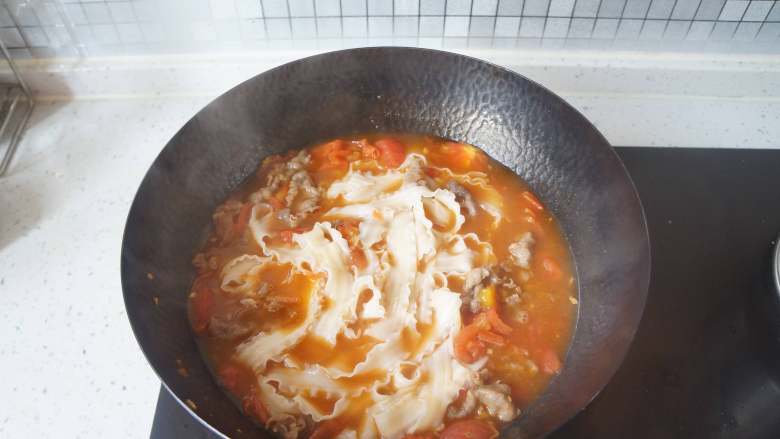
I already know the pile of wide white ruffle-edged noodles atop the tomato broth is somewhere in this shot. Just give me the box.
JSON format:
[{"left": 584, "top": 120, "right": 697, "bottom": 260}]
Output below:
[{"left": 223, "top": 154, "right": 502, "bottom": 438}]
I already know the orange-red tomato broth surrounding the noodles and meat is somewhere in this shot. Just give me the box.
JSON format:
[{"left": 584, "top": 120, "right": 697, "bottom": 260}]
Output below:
[{"left": 189, "top": 135, "right": 577, "bottom": 437}]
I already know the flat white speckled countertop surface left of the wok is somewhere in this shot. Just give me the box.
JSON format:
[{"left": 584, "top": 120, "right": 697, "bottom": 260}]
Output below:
[{"left": 0, "top": 98, "right": 207, "bottom": 438}]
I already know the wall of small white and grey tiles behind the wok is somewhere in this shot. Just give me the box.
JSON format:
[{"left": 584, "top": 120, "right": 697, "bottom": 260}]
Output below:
[{"left": 0, "top": 0, "right": 780, "bottom": 57}]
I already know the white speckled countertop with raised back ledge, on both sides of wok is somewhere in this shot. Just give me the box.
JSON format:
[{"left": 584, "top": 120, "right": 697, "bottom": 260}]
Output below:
[{"left": 0, "top": 47, "right": 780, "bottom": 438}]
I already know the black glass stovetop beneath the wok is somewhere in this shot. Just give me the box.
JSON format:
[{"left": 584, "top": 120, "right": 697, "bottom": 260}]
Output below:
[{"left": 151, "top": 148, "right": 780, "bottom": 439}]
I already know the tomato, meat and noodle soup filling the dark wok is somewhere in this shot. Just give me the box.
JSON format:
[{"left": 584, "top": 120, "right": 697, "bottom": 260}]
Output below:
[{"left": 189, "top": 134, "right": 577, "bottom": 439}]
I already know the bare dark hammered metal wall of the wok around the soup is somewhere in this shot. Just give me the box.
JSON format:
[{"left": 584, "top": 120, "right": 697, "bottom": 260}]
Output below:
[{"left": 121, "top": 48, "right": 650, "bottom": 438}]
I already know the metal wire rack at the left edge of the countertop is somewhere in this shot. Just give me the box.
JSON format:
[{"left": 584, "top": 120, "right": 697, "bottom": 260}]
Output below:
[{"left": 0, "top": 33, "right": 35, "bottom": 177}]
